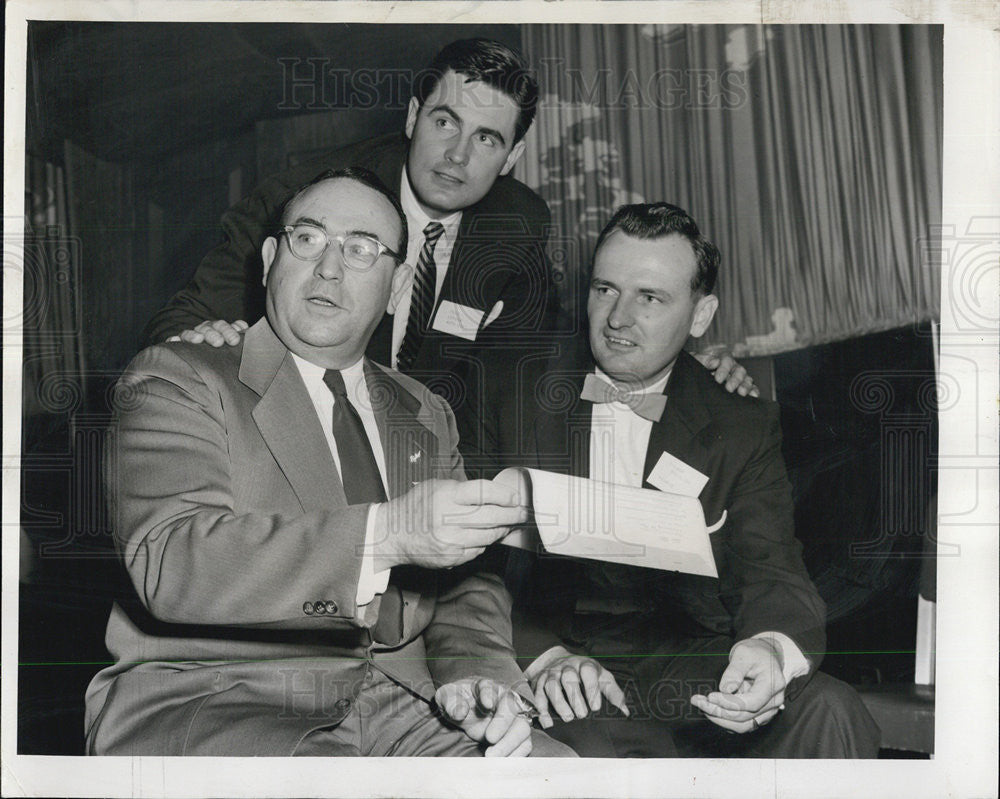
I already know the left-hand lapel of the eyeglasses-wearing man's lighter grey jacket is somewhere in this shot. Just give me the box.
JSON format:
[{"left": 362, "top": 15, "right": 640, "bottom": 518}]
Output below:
[{"left": 240, "top": 319, "right": 347, "bottom": 513}]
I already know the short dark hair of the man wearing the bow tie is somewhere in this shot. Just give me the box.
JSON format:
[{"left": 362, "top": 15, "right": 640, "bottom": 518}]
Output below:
[{"left": 594, "top": 203, "right": 722, "bottom": 295}]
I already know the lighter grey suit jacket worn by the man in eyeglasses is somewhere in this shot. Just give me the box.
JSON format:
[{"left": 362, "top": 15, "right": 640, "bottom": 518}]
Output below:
[{"left": 86, "top": 320, "right": 522, "bottom": 755}]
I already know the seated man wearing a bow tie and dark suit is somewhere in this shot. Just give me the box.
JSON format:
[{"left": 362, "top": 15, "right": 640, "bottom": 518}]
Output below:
[{"left": 460, "top": 203, "right": 878, "bottom": 757}]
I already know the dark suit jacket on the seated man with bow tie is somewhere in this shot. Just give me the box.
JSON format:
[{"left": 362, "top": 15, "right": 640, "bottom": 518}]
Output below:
[{"left": 459, "top": 352, "right": 825, "bottom": 666}]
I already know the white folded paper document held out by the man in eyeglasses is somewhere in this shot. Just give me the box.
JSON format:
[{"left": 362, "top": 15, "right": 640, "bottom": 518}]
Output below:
[{"left": 494, "top": 468, "right": 725, "bottom": 577}]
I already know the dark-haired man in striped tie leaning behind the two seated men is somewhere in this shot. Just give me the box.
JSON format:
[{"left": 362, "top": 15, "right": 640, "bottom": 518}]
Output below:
[{"left": 144, "top": 39, "right": 755, "bottom": 396}]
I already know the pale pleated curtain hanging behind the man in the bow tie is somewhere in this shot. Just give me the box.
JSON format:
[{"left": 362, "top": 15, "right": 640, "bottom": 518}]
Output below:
[{"left": 517, "top": 25, "right": 942, "bottom": 355}]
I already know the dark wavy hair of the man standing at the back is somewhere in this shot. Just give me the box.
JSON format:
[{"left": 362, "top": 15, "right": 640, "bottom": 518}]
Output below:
[{"left": 413, "top": 39, "right": 538, "bottom": 145}]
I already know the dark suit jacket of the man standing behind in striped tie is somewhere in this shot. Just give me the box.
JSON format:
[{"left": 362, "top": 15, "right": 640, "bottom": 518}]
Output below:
[{"left": 143, "top": 134, "right": 555, "bottom": 382}]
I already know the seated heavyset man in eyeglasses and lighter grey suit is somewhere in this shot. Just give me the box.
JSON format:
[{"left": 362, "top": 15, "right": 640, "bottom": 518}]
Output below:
[{"left": 86, "top": 169, "right": 572, "bottom": 756}]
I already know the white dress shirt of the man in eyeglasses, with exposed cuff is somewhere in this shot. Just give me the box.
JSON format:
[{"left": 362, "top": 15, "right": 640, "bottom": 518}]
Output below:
[{"left": 291, "top": 352, "right": 392, "bottom": 618}]
